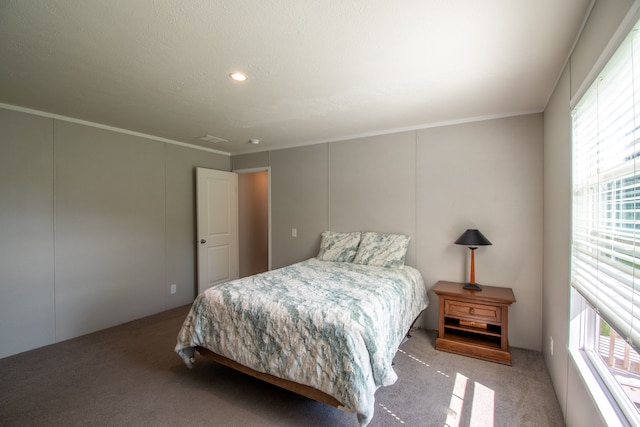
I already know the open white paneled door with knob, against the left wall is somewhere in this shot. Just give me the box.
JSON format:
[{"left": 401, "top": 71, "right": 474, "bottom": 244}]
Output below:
[{"left": 196, "top": 168, "right": 238, "bottom": 293}]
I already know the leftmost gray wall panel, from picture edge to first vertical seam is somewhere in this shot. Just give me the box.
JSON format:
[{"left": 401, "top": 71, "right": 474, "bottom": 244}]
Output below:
[{"left": 0, "top": 109, "right": 56, "bottom": 357}]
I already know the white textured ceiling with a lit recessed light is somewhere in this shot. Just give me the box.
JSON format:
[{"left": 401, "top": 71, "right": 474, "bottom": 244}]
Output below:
[{"left": 0, "top": 0, "right": 591, "bottom": 154}]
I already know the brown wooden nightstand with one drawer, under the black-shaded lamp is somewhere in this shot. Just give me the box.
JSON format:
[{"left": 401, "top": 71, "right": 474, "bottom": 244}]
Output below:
[{"left": 433, "top": 281, "right": 516, "bottom": 365}]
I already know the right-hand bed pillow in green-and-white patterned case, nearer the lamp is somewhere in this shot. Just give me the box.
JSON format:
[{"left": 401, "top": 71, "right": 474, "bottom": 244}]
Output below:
[{"left": 353, "top": 231, "right": 411, "bottom": 268}]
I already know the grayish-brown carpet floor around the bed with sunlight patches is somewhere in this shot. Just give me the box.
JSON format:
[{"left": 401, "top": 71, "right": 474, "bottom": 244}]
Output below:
[{"left": 0, "top": 307, "right": 564, "bottom": 427}]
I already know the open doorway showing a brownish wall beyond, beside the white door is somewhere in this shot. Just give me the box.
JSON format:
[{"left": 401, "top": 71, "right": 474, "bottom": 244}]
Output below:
[{"left": 234, "top": 168, "right": 271, "bottom": 277}]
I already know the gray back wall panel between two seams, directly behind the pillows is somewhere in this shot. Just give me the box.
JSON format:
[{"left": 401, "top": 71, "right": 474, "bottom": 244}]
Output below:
[{"left": 332, "top": 132, "right": 418, "bottom": 266}]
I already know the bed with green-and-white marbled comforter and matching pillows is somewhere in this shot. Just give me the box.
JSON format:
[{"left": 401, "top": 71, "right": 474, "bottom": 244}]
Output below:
[{"left": 175, "top": 232, "right": 428, "bottom": 425}]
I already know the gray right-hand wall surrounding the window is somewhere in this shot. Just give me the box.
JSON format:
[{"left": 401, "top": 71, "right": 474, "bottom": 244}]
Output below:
[{"left": 542, "top": 0, "right": 633, "bottom": 426}]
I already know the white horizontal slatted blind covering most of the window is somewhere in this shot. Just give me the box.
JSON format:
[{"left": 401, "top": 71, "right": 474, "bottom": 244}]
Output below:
[{"left": 572, "top": 24, "right": 640, "bottom": 349}]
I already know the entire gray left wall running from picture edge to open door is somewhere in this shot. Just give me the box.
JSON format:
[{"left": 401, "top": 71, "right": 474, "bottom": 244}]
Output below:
[{"left": 0, "top": 109, "right": 231, "bottom": 357}]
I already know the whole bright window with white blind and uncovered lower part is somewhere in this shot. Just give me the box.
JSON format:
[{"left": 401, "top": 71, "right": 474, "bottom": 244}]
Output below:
[{"left": 571, "top": 18, "right": 640, "bottom": 425}]
